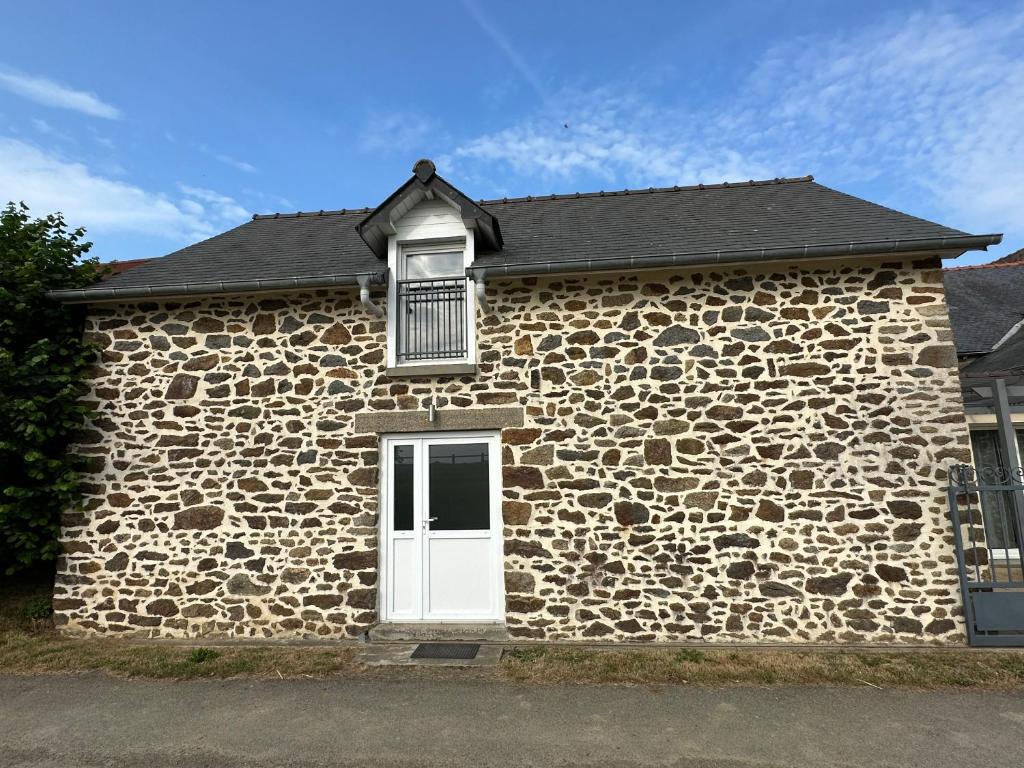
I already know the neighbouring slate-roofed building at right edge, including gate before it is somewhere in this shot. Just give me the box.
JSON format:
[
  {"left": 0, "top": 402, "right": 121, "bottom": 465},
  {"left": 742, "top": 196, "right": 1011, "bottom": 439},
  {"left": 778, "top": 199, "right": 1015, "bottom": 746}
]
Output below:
[{"left": 945, "top": 257, "right": 1024, "bottom": 645}]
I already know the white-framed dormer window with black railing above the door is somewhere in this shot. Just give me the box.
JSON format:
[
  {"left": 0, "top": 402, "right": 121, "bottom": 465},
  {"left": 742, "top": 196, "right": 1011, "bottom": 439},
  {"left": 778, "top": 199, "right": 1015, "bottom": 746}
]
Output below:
[{"left": 391, "top": 244, "right": 470, "bottom": 366}]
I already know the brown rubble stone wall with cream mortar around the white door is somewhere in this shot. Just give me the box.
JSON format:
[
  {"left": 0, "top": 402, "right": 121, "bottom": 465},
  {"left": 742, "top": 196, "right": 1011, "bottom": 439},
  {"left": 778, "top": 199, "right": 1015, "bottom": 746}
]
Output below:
[{"left": 55, "top": 260, "right": 969, "bottom": 643}]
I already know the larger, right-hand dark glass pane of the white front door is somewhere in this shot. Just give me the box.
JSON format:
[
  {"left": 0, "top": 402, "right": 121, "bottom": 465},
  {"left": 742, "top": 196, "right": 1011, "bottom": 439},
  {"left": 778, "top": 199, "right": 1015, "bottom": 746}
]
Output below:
[{"left": 429, "top": 442, "right": 490, "bottom": 530}]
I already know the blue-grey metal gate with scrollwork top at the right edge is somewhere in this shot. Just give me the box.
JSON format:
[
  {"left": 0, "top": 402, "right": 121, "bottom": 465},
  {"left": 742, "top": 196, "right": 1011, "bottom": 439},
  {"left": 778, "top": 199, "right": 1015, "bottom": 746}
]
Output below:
[{"left": 948, "top": 464, "right": 1024, "bottom": 646}]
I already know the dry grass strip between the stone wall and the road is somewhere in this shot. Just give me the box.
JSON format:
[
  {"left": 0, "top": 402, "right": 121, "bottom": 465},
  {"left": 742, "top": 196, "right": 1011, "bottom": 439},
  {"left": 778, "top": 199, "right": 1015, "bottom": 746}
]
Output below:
[{"left": 6, "top": 577, "right": 1024, "bottom": 690}]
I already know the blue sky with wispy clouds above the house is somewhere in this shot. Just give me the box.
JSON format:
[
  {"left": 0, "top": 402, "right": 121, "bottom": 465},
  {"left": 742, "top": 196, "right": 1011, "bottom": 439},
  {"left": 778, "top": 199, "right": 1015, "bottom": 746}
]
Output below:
[{"left": 0, "top": 0, "right": 1024, "bottom": 263}]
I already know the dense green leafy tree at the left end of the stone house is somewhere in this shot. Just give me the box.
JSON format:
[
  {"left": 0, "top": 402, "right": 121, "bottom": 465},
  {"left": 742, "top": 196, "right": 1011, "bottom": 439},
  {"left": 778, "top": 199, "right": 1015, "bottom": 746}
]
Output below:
[{"left": 0, "top": 203, "right": 100, "bottom": 573}]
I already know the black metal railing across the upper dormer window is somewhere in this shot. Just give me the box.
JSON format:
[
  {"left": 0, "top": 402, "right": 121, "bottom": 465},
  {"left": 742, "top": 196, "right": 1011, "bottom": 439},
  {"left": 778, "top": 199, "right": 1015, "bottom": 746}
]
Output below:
[{"left": 395, "top": 278, "right": 467, "bottom": 365}]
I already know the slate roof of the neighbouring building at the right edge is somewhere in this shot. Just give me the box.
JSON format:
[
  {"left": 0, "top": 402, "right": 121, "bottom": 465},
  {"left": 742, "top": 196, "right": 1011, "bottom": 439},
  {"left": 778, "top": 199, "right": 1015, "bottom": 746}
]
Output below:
[{"left": 943, "top": 262, "right": 1024, "bottom": 354}]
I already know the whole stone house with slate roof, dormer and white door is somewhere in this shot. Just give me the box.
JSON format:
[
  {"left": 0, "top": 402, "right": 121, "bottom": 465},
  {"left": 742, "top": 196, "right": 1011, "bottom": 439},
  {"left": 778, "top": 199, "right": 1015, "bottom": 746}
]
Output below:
[{"left": 48, "top": 161, "right": 1000, "bottom": 643}]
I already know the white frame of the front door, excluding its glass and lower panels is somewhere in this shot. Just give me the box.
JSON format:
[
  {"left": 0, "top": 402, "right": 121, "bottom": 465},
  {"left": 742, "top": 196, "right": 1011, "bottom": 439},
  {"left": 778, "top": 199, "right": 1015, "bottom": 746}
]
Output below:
[{"left": 378, "top": 430, "right": 505, "bottom": 624}]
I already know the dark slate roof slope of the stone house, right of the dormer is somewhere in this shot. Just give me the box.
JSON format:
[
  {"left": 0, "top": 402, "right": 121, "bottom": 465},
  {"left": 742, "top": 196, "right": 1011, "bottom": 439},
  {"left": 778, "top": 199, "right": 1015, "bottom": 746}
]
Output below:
[{"left": 476, "top": 176, "right": 966, "bottom": 266}]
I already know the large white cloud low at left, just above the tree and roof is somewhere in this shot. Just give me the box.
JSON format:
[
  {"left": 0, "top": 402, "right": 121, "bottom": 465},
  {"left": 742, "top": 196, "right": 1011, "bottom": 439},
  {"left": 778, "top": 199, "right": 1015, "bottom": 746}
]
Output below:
[{"left": 0, "top": 137, "right": 248, "bottom": 243}]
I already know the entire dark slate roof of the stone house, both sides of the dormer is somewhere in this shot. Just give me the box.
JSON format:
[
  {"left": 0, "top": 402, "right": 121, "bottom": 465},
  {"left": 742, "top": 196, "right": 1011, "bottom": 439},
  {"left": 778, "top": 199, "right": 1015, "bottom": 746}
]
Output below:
[{"left": 55, "top": 176, "right": 998, "bottom": 300}]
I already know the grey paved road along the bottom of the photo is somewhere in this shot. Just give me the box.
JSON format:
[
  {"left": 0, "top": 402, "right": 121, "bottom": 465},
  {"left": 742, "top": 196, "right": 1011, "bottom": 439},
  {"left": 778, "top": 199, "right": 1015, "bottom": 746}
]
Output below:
[{"left": 0, "top": 675, "right": 1024, "bottom": 768}]
